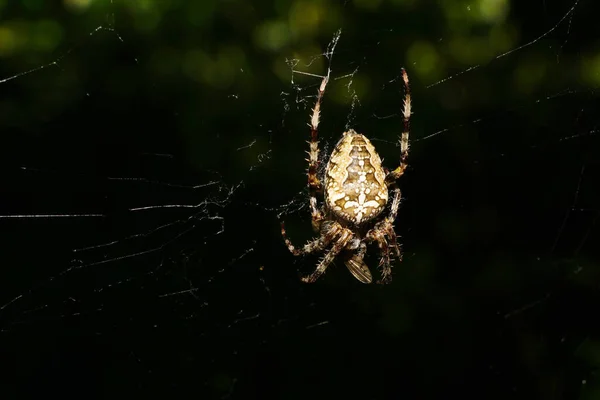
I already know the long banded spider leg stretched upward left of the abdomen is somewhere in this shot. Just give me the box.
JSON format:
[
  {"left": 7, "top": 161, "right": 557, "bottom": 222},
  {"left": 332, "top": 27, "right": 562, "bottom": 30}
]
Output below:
[{"left": 306, "top": 75, "right": 329, "bottom": 232}]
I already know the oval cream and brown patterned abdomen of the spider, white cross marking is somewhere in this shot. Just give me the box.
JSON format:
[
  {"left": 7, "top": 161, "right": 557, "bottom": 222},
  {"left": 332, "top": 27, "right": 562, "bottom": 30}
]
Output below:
[{"left": 325, "top": 129, "right": 388, "bottom": 225}]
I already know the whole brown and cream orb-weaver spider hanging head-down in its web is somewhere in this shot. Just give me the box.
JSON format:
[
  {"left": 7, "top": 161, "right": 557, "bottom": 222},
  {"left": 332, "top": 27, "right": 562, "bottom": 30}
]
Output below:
[{"left": 281, "top": 68, "right": 411, "bottom": 283}]
